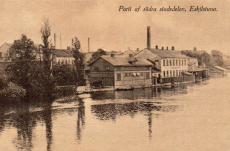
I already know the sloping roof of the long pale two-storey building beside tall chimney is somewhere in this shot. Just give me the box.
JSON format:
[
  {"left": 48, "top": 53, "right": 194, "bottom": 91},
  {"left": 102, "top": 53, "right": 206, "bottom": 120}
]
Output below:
[{"left": 140, "top": 49, "right": 188, "bottom": 59}]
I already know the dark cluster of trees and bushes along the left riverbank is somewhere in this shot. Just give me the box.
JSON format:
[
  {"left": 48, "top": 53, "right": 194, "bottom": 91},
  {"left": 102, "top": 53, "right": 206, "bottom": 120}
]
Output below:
[{"left": 0, "top": 19, "right": 84, "bottom": 100}]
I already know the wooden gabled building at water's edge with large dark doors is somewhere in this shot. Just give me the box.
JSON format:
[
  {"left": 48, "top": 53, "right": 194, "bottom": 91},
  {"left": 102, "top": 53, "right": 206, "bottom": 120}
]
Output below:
[{"left": 88, "top": 54, "right": 152, "bottom": 89}]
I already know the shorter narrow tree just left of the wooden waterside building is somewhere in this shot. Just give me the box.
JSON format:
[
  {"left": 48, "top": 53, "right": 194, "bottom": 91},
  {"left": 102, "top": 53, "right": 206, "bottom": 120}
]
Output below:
[{"left": 72, "top": 37, "right": 85, "bottom": 86}]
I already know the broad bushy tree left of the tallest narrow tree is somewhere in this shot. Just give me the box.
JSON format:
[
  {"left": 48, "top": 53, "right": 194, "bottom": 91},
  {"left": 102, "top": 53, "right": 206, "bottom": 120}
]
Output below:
[{"left": 8, "top": 35, "right": 36, "bottom": 89}]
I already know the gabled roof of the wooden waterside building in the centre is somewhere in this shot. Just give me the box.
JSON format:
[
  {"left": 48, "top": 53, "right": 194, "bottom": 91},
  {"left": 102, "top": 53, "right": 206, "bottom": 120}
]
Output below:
[{"left": 89, "top": 55, "right": 152, "bottom": 66}]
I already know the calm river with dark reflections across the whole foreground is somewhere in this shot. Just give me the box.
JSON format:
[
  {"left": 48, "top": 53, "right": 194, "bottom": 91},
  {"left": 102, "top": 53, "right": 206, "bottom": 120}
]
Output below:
[{"left": 0, "top": 77, "right": 230, "bottom": 151}]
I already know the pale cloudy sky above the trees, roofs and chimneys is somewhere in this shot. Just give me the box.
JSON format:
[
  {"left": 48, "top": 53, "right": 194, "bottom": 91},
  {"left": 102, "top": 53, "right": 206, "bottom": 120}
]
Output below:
[{"left": 0, "top": 0, "right": 230, "bottom": 54}]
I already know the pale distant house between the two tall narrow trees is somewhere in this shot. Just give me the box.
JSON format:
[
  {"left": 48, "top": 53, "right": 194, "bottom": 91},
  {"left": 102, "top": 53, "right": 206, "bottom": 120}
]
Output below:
[{"left": 52, "top": 49, "right": 74, "bottom": 65}]
